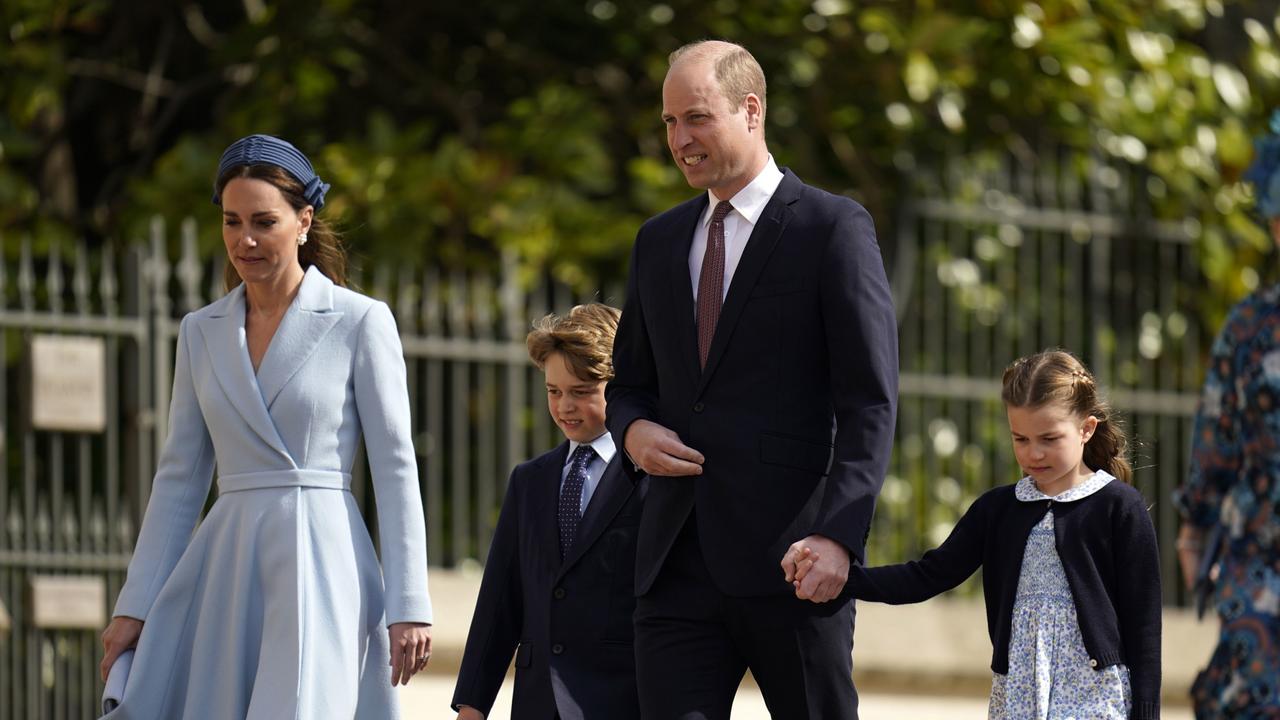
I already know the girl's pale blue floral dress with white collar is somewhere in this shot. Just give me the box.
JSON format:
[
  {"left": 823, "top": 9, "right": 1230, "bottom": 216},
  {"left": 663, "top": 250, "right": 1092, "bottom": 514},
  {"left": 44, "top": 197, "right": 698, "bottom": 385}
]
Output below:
[{"left": 988, "top": 470, "right": 1133, "bottom": 720}]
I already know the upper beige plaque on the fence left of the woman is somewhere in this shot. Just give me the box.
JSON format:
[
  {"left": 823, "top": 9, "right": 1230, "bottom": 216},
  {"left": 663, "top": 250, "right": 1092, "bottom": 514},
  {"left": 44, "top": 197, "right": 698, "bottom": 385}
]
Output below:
[{"left": 31, "top": 334, "right": 106, "bottom": 433}]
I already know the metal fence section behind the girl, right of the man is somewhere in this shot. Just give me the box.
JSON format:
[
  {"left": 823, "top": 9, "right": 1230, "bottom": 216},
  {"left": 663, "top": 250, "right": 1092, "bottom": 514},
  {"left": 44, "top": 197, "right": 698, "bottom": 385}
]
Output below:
[{"left": 870, "top": 147, "right": 1216, "bottom": 602}]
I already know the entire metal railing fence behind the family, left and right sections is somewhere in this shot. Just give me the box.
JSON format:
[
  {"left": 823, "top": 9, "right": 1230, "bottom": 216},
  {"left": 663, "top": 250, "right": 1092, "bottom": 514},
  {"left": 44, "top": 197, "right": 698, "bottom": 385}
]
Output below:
[{"left": 0, "top": 146, "right": 1212, "bottom": 719}]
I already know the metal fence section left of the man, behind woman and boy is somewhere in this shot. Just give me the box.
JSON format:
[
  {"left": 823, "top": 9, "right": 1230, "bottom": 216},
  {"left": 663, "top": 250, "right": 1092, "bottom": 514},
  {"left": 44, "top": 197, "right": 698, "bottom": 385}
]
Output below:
[{"left": 0, "top": 220, "right": 622, "bottom": 719}]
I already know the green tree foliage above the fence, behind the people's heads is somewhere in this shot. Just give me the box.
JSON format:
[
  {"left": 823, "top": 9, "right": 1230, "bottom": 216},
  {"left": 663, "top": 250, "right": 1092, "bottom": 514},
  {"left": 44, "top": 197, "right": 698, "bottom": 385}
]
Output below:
[{"left": 0, "top": 0, "right": 1280, "bottom": 311}]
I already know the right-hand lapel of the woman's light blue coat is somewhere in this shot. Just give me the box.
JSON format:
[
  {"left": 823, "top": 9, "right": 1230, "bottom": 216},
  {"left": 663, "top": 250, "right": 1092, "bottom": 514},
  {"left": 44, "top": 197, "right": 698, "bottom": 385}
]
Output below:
[{"left": 257, "top": 265, "right": 342, "bottom": 410}]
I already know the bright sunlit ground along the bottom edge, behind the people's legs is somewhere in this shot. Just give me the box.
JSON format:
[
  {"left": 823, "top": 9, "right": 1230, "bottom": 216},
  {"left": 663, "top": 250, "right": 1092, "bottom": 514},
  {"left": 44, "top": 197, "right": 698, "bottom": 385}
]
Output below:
[{"left": 401, "top": 674, "right": 1192, "bottom": 720}]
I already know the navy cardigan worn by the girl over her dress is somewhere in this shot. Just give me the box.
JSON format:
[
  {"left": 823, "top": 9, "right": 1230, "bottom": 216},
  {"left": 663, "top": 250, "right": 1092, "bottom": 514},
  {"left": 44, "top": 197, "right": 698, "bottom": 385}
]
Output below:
[{"left": 849, "top": 480, "right": 1161, "bottom": 720}]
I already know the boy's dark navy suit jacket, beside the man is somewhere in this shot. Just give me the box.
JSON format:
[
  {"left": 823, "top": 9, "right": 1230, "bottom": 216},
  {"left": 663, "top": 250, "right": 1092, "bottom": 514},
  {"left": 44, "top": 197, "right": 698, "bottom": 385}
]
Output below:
[{"left": 453, "top": 441, "right": 646, "bottom": 720}]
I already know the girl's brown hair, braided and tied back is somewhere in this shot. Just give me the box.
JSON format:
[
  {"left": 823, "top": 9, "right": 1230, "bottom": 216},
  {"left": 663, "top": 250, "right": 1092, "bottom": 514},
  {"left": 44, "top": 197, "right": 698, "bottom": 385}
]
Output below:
[{"left": 1000, "top": 350, "right": 1133, "bottom": 483}]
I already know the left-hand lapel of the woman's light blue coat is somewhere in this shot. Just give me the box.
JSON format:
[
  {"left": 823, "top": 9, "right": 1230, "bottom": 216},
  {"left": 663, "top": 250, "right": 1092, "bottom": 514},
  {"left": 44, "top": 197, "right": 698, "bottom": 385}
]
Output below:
[{"left": 200, "top": 284, "right": 293, "bottom": 465}]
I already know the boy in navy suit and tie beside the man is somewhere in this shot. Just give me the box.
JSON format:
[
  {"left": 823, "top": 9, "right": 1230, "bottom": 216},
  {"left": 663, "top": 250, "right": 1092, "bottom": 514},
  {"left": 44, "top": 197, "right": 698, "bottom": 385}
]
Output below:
[{"left": 453, "top": 304, "right": 648, "bottom": 720}]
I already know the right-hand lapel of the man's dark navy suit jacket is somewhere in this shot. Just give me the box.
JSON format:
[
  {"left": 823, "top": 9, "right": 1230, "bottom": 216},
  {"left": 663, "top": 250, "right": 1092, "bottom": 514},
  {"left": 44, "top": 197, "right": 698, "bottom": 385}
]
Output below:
[{"left": 694, "top": 172, "right": 800, "bottom": 397}]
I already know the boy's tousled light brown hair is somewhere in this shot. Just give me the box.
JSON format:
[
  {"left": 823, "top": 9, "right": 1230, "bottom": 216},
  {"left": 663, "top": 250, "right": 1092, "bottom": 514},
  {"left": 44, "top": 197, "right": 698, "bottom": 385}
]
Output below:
[{"left": 525, "top": 302, "right": 621, "bottom": 380}]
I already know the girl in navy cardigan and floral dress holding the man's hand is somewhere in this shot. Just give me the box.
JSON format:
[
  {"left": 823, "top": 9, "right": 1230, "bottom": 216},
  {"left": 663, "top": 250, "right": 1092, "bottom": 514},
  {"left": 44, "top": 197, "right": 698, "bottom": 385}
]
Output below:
[{"left": 801, "top": 351, "right": 1161, "bottom": 720}]
